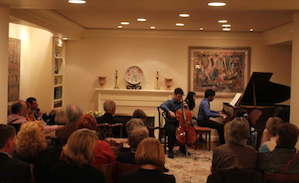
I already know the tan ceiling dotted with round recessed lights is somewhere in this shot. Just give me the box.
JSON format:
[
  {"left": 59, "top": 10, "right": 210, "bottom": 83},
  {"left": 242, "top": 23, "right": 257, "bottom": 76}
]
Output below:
[{"left": 0, "top": 0, "right": 299, "bottom": 32}]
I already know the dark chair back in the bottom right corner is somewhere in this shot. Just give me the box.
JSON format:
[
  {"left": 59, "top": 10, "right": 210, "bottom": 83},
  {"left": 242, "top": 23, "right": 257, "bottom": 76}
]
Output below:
[{"left": 264, "top": 172, "right": 299, "bottom": 183}]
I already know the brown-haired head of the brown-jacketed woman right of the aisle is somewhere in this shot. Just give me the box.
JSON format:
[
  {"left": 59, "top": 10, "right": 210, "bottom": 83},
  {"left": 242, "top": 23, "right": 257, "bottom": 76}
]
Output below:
[{"left": 228, "top": 117, "right": 250, "bottom": 145}]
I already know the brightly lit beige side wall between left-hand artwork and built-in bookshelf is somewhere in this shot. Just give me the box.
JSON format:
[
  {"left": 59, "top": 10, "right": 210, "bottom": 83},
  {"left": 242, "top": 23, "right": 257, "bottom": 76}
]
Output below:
[{"left": 9, "top": 23, "right": 53, "bottom": 111}]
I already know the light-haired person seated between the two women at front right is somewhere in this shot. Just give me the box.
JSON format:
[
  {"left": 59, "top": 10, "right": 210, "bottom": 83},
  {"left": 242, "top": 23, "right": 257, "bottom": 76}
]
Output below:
[{"left": 259, "top": 117, "right": 283, "bottom": 153}]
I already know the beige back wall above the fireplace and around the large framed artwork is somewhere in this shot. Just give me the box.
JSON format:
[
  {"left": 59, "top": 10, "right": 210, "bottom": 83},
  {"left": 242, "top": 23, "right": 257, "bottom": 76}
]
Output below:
[{"left": 65, "top": 30, "right": 291, "bottom": 113}]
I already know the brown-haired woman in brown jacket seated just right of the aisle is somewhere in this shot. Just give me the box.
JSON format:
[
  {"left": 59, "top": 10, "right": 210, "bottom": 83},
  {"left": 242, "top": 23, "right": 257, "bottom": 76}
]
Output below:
[{"left": 211, "top": 117, "right": 258, "bottom": 172}]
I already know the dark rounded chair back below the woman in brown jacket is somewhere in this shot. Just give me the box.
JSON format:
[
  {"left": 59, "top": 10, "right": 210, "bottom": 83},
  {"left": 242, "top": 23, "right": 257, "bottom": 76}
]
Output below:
[{"left": 207, "top": 169, "right": 263, "bottom": 183}]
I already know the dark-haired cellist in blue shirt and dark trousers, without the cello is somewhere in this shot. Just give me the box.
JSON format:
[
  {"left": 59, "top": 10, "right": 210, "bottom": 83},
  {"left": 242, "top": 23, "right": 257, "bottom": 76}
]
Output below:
[{"left": 160, "top": 88, "right": 190, "bottom": 158}]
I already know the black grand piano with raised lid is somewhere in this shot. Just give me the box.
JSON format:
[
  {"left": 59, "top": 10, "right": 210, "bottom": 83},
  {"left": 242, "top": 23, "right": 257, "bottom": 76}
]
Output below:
[{"left": 223, "top": 72, "right": 291, "bottom": 131}]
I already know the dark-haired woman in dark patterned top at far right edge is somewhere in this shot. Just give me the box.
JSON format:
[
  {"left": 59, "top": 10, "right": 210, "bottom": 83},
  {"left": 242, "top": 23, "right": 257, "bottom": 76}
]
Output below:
[{"left": 258, "top": 123, "right": 299, "bottom": 173}]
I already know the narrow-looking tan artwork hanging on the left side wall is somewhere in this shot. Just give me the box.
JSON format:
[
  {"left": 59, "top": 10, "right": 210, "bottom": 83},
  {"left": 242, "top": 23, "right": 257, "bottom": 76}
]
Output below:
[{"left": 8, "top": 38, "right": 21, "bottom": 102}]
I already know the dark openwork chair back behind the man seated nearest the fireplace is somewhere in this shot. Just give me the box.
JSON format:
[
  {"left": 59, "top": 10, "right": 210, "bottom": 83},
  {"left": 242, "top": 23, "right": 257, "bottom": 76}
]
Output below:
[{"left": 97, "top": 123, "right": 124, "bottom": 140}]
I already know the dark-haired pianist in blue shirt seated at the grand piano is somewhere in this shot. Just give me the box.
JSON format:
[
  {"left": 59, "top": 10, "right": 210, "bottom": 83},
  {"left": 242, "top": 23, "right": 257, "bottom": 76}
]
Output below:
[{"left": 197, "top": 89, "right": 227, "bottom": 144}]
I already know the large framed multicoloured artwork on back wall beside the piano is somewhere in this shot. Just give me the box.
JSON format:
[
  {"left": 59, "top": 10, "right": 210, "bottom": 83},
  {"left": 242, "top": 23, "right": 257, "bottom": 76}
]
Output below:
[{"left": 189, "top": 46, "right": 250, "bottom": 95}]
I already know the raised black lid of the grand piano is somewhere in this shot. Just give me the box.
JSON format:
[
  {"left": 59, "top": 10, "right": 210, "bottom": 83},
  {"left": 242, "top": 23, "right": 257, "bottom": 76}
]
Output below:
[{"left": 239, "top": 72, "right": 291, "bottom": 106}]
